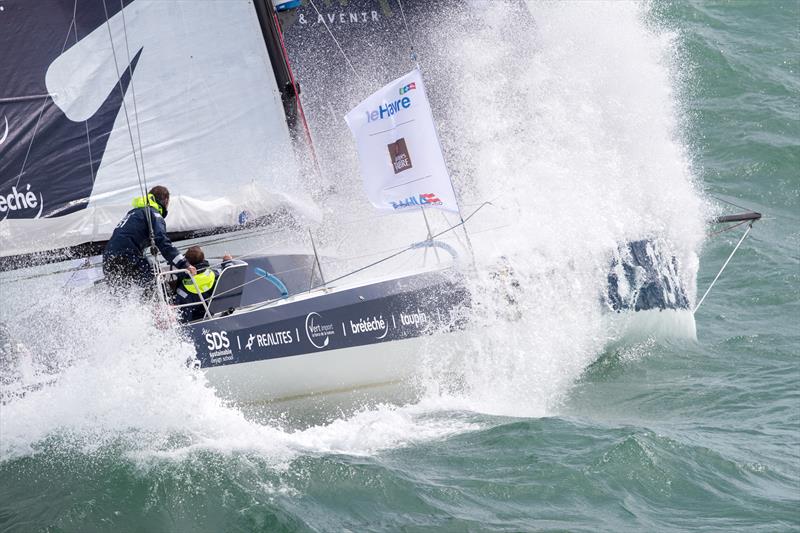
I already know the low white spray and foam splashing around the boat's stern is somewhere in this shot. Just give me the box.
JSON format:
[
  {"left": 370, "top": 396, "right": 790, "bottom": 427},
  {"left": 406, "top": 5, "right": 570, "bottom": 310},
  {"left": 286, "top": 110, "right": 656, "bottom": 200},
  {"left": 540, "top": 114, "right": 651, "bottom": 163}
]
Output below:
[{"left": 0, "top": 280, "right": 475, "bottom": 469}]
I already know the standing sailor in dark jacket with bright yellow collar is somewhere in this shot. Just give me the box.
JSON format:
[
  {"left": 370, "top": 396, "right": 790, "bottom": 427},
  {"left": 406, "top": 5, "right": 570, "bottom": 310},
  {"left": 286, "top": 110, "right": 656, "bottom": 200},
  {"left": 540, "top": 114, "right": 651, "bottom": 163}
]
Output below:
[{"left": 103, "top": 185, "right": 196, "bottom": 287}]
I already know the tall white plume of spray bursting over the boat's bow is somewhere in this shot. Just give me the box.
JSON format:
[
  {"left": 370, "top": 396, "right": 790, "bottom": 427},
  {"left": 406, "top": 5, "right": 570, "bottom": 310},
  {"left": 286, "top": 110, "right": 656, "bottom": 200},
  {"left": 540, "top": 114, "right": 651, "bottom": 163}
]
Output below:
[{"left": 374, "top": 2, "right": 707, "bottom": 415}]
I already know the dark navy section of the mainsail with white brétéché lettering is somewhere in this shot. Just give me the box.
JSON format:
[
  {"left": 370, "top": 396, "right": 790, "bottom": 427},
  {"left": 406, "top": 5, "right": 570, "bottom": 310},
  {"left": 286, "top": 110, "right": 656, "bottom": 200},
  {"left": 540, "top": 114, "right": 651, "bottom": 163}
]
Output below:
[{"left": 0, "top": 0, "right": 138, "bottom": 219}]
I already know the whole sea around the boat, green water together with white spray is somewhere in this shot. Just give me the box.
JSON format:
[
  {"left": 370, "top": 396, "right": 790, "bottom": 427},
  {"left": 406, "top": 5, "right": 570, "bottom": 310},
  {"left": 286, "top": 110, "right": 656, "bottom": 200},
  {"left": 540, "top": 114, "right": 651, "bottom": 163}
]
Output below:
[{"left": 0, "top": 1, "right": 800, "bottom": 532}]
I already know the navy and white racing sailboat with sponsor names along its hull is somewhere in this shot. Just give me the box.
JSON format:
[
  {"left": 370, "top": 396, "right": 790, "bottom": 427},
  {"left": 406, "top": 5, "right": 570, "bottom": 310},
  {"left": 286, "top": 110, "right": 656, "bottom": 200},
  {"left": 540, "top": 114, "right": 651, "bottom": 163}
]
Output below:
[{"left": 0, "top": 0, "right": 756, "bottom": 401}]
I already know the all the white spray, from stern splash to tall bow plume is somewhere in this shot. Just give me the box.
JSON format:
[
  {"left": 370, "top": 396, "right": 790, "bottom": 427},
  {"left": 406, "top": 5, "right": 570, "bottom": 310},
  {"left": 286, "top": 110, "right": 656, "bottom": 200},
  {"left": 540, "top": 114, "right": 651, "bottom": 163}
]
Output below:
[{"left": 0, "top": 3, "right": 702, "bottom": 458}]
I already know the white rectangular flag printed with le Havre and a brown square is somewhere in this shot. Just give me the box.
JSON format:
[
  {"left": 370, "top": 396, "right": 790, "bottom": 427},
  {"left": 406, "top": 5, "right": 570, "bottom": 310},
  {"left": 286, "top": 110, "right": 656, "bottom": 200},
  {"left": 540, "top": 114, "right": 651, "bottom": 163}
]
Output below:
[{"left": 345, "top": 70, "right": 458, "bottom": 213}]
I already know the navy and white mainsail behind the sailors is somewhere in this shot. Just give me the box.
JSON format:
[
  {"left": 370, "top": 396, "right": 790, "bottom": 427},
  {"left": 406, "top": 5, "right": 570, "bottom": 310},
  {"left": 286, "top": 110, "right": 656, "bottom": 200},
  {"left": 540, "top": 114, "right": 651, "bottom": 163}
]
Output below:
[{"left": 0, "top": 0, "right": 313, "bottom": 256}]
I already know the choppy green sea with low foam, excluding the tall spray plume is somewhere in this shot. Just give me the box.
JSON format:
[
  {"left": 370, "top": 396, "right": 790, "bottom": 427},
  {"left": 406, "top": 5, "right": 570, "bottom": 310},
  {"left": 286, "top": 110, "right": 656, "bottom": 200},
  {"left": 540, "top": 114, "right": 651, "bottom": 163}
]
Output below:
[{"left": 0, "top": 1, "right": 800, "bottom": 532}]
